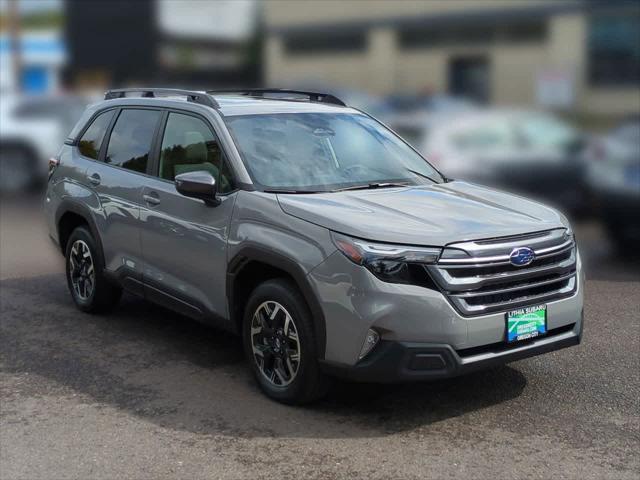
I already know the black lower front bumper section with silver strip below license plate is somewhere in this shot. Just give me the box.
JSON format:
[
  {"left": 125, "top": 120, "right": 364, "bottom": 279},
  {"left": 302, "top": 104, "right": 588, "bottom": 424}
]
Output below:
[{"left": 322, "top": 315, "right": 583, "bottom": 383}]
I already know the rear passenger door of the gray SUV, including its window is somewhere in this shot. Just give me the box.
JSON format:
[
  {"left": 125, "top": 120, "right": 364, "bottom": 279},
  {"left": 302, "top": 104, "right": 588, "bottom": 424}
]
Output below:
[{"left": 85, "top": 108, "right": 162, "bottom": 293}]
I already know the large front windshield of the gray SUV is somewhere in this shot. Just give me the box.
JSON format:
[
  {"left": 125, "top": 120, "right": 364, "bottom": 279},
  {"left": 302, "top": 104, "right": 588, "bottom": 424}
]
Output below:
[{"left": 225, "top": 113, "right": 442, "bottom": 192}]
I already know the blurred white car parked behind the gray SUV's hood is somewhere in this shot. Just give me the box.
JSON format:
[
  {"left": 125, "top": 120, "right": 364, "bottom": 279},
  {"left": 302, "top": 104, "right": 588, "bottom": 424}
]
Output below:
[{"left": 387, "top": 109, "right": 586, "bottom": 213}]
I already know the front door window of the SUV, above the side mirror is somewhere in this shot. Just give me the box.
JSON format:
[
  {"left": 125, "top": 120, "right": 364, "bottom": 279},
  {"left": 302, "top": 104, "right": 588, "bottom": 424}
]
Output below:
[{"left": 159, "top": 113, "right": 232, "bottom": 193}]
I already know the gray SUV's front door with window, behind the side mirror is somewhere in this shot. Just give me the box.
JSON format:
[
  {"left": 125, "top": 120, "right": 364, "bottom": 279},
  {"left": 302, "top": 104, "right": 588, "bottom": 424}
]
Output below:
[{"left": 140, "top": 111, "right": 236, "bottom": 318}]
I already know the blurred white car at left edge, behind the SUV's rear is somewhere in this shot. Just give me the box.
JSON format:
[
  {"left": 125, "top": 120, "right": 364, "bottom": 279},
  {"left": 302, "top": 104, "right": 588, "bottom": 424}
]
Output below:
[{"left": 0, "top": 94, "right": 87, "bottom": 192}]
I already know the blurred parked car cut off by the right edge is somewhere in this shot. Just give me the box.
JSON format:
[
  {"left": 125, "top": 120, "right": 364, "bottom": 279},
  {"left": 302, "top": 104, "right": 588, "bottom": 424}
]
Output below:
[{"left": 585, "top": 116, "right": 640, "bottom": 248}]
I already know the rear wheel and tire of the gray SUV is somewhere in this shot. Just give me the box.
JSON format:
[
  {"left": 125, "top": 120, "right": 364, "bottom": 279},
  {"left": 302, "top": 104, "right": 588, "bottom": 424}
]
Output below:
[{"left": 65, "top": 227, "right": 122, "bottom": 313}]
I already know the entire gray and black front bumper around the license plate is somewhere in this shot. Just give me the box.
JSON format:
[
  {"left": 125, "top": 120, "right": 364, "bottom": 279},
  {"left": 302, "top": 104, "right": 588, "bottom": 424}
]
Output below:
[{"left": 307, "top": 246, "right": 584, "bottom": 374}]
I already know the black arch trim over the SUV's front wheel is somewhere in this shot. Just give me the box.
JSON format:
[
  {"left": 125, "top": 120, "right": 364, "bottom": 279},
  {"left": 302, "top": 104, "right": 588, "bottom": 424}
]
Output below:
[{"left": 226, "top": 246, "right": 326, "bottom": 359}]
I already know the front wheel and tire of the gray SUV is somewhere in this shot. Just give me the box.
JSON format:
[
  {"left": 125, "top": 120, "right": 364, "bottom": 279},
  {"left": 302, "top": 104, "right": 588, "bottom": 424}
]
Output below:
[{"left": 242, "top": 278, "right": 329, "bottom": 405}]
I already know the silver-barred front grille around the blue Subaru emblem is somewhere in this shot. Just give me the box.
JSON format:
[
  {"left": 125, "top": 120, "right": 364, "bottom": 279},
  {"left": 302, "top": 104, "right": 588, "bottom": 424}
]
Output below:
[{"left": 426, "top": 229, "right": 577, "bottom": 316}]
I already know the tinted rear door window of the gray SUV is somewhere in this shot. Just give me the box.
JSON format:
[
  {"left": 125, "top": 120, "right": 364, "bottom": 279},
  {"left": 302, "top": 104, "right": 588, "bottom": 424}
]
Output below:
[{"left": 105, "top": 110, "right": 160, "bottom": 173}]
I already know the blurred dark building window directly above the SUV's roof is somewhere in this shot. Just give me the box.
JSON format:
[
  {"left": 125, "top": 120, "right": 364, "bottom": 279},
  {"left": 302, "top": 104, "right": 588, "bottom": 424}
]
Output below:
[{"left": 284, "top": 31, "right": 366, "bottom": 55}]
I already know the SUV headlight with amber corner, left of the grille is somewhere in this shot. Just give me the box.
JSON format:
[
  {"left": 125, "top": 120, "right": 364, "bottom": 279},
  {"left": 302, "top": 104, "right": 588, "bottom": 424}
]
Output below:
[{"left": 331, "top": 232, "right": 441, "bottom": 285}]
